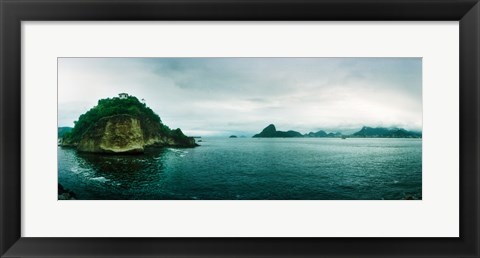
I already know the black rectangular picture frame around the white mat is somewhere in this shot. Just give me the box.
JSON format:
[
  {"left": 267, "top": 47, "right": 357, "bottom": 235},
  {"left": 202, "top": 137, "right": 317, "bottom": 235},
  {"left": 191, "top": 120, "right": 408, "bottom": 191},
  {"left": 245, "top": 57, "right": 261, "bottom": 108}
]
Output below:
[{"left": 0, "top": 0, "right": 480, "bottom": 257}]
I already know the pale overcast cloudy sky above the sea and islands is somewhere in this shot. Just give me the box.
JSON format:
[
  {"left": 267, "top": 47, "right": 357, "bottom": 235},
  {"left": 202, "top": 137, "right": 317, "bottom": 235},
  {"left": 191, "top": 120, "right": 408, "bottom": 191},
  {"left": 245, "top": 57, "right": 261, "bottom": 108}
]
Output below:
[{"left": 58, "top": 58, "right": 422, "bottom": 136}]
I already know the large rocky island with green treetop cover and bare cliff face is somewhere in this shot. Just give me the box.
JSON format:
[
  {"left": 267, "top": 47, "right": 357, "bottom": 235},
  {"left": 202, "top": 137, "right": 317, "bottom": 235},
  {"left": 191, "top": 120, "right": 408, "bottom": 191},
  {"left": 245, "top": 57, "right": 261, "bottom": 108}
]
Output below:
[{"left": 58, "top": 93, "right": 198, "bottom": 153}]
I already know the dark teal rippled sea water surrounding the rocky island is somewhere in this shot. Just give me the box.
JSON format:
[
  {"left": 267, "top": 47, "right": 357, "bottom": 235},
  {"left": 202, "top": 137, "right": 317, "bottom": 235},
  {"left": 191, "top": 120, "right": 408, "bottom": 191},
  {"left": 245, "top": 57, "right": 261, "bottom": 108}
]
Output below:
[{"left": 58, "top": 138, "right": 422, "bottom": 200}]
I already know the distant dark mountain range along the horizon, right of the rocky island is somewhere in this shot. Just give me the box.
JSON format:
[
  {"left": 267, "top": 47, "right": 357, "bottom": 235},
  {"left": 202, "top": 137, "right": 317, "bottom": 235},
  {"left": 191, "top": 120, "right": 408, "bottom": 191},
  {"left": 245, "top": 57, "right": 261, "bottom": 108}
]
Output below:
[{"left": 253, "top": 124, "right": 422, "bottom": 138}]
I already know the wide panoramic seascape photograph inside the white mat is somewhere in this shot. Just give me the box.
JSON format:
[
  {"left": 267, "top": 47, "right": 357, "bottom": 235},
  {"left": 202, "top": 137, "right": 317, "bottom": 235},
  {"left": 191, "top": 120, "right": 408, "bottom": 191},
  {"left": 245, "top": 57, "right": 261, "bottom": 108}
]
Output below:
[{"left": 57, "top": 57, "right": 422, "bottom": 201}]
